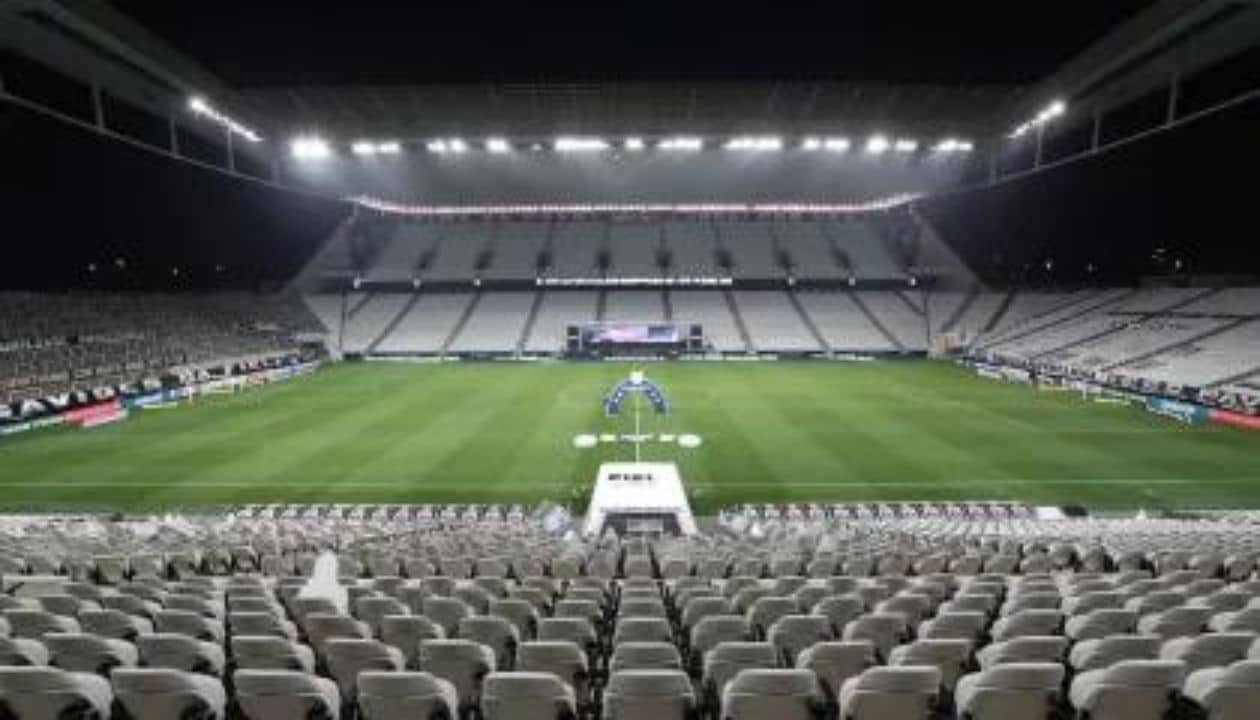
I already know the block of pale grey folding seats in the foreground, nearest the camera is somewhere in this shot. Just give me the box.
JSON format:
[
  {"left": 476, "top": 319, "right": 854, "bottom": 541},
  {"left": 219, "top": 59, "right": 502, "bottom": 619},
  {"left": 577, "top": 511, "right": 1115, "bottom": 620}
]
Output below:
[{"left": 6, "top": 547, "right": 1256, "bottom": 717}]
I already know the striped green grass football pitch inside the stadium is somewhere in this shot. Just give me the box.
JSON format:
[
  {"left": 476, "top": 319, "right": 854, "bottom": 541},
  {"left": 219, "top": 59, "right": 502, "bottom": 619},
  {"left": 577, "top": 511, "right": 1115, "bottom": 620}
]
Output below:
[{"left": 0, "top": 361, "right": 1260, "bottom": 513}]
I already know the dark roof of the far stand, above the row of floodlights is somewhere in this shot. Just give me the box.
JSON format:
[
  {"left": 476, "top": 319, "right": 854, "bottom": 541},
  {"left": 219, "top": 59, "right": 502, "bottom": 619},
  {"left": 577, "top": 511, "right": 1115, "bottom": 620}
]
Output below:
[{"left": 244, "top": 82, "right": 1019, "bottom": 140}]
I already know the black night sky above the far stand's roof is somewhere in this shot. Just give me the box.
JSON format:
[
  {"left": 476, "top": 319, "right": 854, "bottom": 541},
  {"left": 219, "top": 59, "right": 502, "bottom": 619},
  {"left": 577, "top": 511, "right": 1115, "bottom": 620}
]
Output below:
[{"left": 112, "top": 0, "right": 1152, "bottom": 87}]
